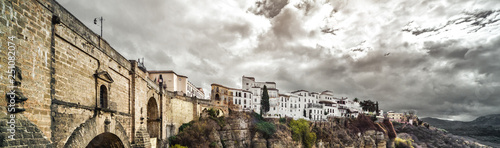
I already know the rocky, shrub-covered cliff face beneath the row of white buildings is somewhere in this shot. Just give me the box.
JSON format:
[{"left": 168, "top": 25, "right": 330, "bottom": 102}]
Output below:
[{"left": 169, "top": 112, "right": 389, "bottom": 148}]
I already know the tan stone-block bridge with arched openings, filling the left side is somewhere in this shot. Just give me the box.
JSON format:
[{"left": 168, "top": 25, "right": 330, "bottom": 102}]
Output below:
[{"left": 0, "top": 0, "right": 210, "bottom": 148}]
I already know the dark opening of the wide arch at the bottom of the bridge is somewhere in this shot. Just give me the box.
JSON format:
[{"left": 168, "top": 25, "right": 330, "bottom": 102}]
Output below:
[{"left": 86, "top": 132, "right": 125, "bottom": 148}]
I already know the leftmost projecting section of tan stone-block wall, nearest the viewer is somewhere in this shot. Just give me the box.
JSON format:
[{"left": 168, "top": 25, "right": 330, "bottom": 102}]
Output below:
[{"left": 0, "top": 0, "right": 52, "bottom": 137}]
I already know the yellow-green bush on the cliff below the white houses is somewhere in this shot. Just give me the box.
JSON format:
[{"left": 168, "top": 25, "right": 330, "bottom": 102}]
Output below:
[{"left": 289, "top": 119, "right": 316, "bottom": 148}]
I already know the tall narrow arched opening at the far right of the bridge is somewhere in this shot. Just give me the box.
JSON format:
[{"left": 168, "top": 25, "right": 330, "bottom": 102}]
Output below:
[{"left": 147, "top": 98, "right": 160, "bottom": 138}]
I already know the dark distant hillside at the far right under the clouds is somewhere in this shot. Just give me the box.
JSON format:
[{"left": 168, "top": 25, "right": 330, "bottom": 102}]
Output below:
[{"left": 422, "top": 114, "right": 500, "bottom": 147}]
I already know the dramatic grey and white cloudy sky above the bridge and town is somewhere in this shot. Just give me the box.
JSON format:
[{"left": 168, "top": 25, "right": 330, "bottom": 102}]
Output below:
[{"left": 58, "top": 0, "right": 500, "bottom": 120}]
